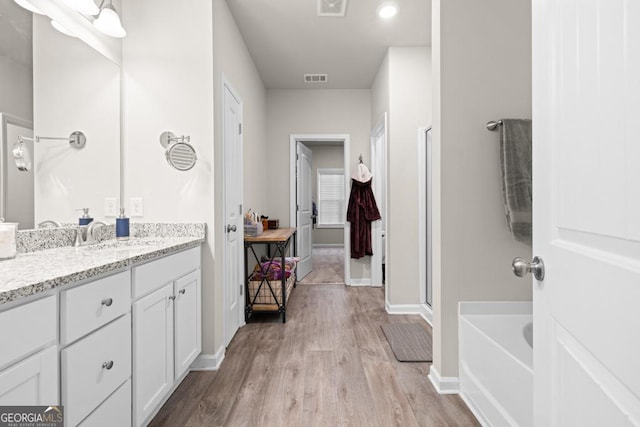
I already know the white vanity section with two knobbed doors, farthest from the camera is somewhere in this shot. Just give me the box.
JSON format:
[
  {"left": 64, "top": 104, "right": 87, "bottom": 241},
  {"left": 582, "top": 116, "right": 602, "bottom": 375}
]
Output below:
[{"left": 132, "top": 247, "right": 202, "bottom": 426}]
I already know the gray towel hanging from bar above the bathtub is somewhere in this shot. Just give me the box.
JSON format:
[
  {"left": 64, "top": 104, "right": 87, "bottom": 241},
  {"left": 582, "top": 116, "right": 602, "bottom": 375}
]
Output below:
[{"left": 500, "top": 119, "right": 533, "bottom": 244}]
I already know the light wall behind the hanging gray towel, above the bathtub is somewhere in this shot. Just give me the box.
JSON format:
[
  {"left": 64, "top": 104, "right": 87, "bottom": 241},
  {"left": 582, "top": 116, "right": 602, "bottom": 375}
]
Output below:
[{"left": 433, "top": 0, "right": 531, "bottom": 377}]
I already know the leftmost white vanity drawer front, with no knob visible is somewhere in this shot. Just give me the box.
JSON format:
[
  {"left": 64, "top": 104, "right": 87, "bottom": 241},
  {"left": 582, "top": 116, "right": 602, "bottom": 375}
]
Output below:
[{"left": 0, "top": 296, "right": 58, "bottom": 369}]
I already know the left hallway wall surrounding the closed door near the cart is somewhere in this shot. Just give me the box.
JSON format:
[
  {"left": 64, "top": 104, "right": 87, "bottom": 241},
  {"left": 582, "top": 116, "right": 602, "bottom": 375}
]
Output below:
[{"left": 209, "top": 0, "right": 273, "bottom": 349}]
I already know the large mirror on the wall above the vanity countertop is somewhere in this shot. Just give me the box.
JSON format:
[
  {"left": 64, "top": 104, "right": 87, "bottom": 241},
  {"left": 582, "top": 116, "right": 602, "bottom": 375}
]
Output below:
[{"left": 0, "top": 0, "right": 120, "bottom": 229}]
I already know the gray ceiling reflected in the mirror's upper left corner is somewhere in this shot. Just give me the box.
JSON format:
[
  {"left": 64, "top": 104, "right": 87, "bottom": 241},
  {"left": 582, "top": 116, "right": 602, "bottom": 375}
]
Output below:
[{"left": 0, "top": 0, "right": 32, "bottom": 67}]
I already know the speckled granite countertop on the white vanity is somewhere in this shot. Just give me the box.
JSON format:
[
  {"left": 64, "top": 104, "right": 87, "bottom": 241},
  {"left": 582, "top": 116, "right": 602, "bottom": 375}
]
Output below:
[{"left": 0, "top": 235, "right": 205, "bottom": 305}]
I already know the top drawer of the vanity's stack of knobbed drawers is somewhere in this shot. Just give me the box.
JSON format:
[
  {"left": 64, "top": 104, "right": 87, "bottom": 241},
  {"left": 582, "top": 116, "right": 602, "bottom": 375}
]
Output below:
[{"left": 60, "top": 271, "right": 131, "bottom": 345}]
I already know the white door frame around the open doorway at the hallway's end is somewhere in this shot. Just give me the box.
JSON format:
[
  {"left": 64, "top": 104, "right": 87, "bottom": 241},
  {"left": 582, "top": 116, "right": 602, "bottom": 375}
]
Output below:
[{"left": 289, "top": 133, "right": 351, "bottom": 286}]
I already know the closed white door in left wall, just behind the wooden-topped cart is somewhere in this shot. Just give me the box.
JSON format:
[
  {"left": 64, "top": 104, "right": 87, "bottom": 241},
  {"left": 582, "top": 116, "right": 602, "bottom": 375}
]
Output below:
[{"left": 221, "top": 83, "right": 244, "bottom": 346}]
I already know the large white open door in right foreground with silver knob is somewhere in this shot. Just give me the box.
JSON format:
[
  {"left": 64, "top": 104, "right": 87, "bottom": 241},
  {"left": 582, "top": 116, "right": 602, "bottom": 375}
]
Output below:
[{"left": 533, "top": 0, "right": 640, "bottom": 426}]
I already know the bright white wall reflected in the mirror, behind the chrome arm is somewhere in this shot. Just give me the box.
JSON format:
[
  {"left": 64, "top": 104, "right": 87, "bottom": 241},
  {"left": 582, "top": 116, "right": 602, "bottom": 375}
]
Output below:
[{"left": 33, "top": 15, "right": 120, "bottom": 226}]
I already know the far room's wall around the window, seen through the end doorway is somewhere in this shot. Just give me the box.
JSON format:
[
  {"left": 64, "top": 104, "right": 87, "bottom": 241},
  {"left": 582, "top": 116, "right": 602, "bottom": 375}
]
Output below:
[{"left": 305, "top": 143, "right": 349, "bottom": 245}]
